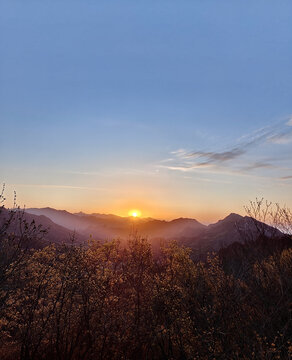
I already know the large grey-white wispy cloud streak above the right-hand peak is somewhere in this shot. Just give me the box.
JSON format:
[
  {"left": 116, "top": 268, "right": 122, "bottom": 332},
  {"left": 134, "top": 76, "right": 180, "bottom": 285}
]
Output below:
[{"left": 159, "top": 119, "right": 292, "bottom": 179}]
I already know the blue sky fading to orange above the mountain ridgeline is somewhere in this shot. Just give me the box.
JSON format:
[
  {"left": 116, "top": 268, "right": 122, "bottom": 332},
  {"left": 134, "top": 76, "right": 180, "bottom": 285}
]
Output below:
[{"left": 0, "top": 0, "right": 292, "bottom": 222}]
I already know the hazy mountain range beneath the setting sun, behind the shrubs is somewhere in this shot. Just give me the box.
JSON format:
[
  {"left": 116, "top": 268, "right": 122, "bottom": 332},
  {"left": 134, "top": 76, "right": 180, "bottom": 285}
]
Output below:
[{"left": 20, "top": 207, "right": 282, "bottom": 251}]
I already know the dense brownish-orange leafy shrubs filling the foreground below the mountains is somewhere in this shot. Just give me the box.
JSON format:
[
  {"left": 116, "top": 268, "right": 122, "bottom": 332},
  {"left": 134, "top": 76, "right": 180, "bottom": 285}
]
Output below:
[{"left": 0, "top": 204, "right": 292, "bottom": 360}]
